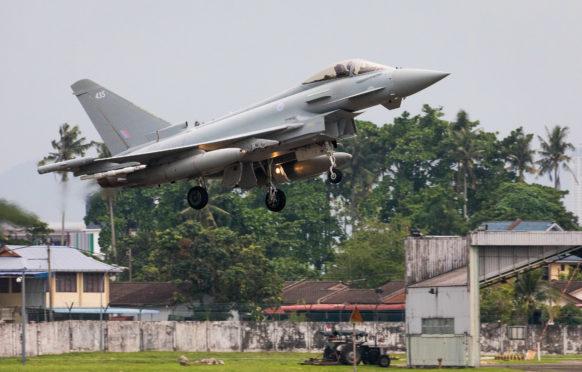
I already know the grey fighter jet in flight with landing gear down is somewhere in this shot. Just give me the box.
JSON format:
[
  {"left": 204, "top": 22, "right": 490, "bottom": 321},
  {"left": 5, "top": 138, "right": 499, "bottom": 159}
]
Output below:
[{"left": 38, "top": 59, "right": 449, "bottom": 212}]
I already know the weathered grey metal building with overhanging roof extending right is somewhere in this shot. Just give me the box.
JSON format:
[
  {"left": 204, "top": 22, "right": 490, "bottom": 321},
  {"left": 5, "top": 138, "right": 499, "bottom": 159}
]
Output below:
[{"left": 404, "top": 220, "right": 582, "bottom": 367}]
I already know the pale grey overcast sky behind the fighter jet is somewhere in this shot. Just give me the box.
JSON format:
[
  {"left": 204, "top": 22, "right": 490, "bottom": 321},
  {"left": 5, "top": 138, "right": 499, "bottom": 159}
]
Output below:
[{"left": 0, "top": 0, "right": 582, "bottom": 221}]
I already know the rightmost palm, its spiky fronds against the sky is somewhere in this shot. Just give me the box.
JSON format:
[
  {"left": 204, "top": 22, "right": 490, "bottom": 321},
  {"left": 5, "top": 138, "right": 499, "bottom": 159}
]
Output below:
[{"left": 537, "top": 125, "right": 578, "bottom": 190}]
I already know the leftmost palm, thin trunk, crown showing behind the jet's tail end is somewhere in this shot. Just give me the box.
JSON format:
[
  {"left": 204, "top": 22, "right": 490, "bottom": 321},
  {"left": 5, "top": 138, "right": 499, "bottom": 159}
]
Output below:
[{"left": 38, "top": 123, "right": 93, "bottom": 245}]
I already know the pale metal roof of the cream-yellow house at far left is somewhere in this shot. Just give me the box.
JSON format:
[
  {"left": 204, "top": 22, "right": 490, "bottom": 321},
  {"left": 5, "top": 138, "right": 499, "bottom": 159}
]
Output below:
[{"left": 0, "top": 245, "right": 121, "bottom": 273}]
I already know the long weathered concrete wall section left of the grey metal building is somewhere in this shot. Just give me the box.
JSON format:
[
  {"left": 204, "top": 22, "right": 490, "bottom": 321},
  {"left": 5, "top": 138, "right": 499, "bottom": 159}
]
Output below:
[{"left": 0, "top": 320, "right": 405, "bottom": 357}]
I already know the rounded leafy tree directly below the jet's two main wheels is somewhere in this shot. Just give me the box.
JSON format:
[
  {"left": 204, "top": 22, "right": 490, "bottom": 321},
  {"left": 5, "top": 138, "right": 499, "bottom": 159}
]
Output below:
[{"left": 148, "top": 220, "right": 282, "bottom": 303}]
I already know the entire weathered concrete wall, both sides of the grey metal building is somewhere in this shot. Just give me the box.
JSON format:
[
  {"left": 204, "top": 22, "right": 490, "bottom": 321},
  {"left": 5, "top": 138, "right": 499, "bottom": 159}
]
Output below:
[{"left": 0, "top": 320, "right": 582, "bottom": 357}]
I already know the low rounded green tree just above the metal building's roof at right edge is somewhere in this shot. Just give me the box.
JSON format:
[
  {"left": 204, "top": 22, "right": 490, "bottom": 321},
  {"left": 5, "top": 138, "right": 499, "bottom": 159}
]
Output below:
[{"left": 471, "top": 182, "right": 578, "bottom": 230}]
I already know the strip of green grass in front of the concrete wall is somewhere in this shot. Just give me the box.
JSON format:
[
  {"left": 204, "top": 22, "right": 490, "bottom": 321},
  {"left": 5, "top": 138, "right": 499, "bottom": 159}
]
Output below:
[{"left": 0, "top": 351, "right": 524, "bottom": 372}]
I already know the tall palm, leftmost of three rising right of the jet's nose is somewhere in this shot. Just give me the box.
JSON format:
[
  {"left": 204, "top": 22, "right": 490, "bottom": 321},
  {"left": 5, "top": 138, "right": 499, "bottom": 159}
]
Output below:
[{"left": 452, "top": 110, "right": 483, "bottom": 219}]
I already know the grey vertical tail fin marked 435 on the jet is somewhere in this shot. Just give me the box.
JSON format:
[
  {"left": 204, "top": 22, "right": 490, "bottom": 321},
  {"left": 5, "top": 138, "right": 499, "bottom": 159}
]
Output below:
[{"left": 71, "top": 79, "right": 170, "bottom": 155}]
